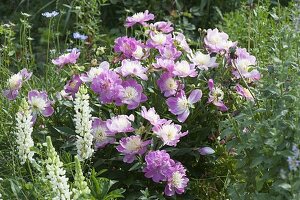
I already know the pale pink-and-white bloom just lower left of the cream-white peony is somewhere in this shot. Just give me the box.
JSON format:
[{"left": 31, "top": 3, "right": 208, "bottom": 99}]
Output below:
[{"left": 172, "top": 60, "right": 197, "bottom": 77}]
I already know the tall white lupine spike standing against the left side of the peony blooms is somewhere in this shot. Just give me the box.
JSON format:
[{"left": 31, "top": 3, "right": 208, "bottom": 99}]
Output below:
[{"left": 74, "top": 86, "right": 94, "bottom": 160}]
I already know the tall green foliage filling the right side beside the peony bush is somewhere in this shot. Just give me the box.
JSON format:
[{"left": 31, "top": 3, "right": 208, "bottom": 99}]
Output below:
[{"left": 222, "top": 1, "right": 300, "bottom": 199}]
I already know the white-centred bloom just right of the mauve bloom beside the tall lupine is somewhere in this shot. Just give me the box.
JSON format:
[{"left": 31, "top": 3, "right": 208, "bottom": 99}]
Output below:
[{"left": 106, "top": 115, "right": 134, "bottom": 135}]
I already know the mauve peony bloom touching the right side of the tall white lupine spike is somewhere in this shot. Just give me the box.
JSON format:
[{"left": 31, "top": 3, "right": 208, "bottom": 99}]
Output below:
[{"left": 91, "top": 118, "right": 116, "bottom": 149}]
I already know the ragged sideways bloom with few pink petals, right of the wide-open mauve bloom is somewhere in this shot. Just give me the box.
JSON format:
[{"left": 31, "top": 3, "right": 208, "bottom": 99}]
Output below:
[{"left": 208, "top": 79, "right": 228, "bottom": 111}]
